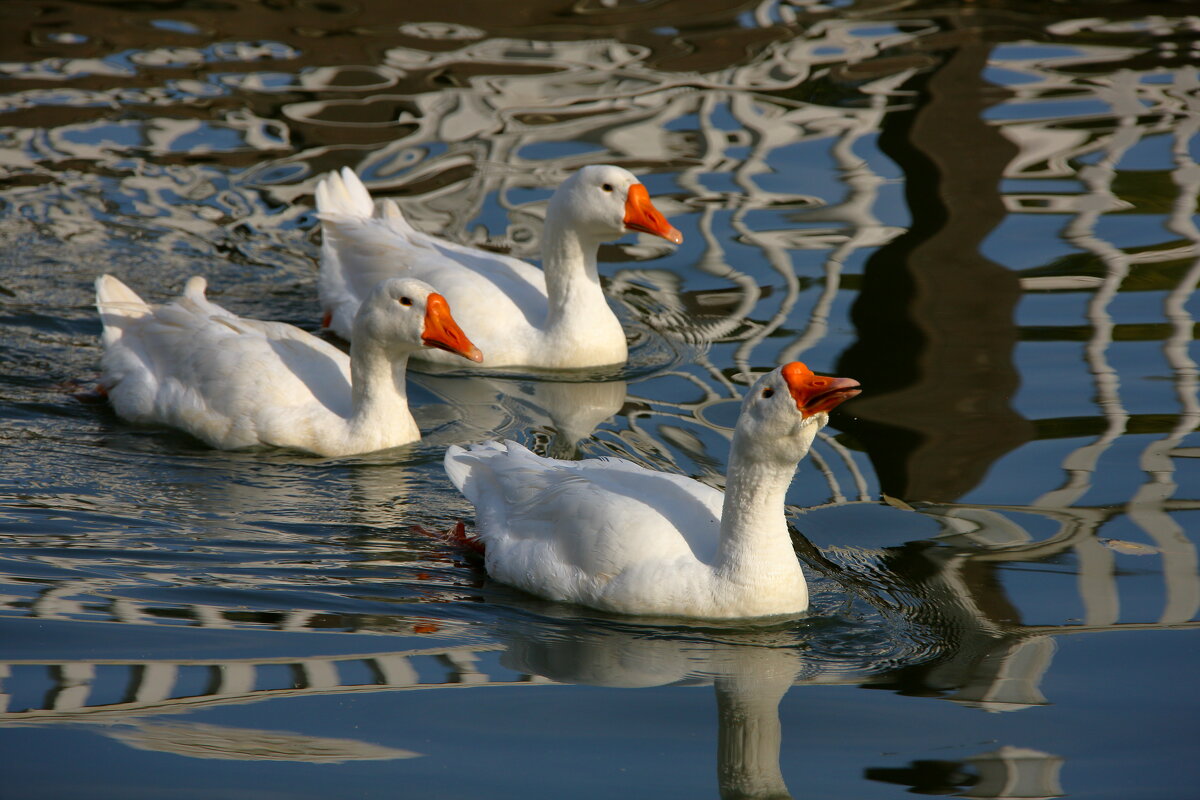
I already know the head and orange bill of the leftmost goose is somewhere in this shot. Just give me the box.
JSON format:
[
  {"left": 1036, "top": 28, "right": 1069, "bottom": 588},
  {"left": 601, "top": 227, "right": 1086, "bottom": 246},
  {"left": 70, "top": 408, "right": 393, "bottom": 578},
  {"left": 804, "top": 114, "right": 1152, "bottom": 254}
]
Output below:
[{"left": 354, "top": 278, "right": 484, "bottom": 362}]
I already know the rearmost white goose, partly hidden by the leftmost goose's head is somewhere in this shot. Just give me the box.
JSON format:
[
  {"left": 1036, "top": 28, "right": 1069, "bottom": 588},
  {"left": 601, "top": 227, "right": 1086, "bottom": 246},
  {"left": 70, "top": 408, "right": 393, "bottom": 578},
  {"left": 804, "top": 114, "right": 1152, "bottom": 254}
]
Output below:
[{"left": 316, "top": 167, "right": 683, "bottom": 369}]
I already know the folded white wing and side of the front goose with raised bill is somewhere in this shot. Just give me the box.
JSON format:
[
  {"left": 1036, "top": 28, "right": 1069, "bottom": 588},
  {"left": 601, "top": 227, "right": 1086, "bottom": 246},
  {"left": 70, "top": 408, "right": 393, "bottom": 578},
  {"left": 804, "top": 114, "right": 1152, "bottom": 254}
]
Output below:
[{"left": 446, "top": 441, "right": 724, "bottom": 600}]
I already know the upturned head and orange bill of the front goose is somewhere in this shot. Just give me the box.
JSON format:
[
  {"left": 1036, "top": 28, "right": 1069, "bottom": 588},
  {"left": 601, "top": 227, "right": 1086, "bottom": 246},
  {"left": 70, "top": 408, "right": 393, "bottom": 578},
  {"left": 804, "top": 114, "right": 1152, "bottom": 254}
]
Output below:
[{"left": 734, "top": 361, "right": 862, "bottom": 467}]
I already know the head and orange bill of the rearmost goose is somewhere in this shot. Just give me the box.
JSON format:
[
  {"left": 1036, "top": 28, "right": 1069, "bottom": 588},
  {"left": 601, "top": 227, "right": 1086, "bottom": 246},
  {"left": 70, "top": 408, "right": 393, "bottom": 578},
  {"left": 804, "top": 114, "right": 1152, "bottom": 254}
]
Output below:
[{"left": 547, "top": 166, "right": 683, "bottom": 245}]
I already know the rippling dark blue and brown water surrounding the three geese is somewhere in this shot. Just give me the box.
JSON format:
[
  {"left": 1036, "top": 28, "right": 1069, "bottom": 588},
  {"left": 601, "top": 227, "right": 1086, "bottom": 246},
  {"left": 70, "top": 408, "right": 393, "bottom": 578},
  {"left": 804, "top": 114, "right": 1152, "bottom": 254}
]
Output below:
[{"left": 0, "top": 0, "right": 1200, "bottom": 799}]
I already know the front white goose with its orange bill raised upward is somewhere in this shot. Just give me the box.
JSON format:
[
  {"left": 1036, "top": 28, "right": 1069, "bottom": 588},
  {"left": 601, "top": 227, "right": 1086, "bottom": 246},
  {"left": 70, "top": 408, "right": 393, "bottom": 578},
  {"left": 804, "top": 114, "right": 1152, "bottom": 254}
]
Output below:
[{"left": 445, "top": 361, "right": 859, "bottom": 619}]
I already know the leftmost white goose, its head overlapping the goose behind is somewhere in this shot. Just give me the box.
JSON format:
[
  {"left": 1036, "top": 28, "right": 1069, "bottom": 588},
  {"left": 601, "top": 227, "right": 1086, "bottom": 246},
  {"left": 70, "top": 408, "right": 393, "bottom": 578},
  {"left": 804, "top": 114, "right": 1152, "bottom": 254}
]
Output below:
[{"left": 96, "top": 275, "right": 482, "bottom": 456}]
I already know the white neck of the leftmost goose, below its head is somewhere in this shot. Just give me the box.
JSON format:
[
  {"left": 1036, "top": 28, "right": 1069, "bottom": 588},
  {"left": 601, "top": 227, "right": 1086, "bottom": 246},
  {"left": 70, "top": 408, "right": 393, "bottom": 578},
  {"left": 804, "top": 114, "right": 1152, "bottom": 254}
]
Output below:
[{"left": 349, "top": 335, "right": 420, "bottom": 447}]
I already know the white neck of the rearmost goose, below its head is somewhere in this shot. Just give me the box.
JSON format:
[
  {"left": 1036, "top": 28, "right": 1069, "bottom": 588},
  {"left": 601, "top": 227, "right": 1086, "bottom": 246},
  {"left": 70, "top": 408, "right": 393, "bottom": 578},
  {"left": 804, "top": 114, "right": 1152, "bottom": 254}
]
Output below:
[{"left": 542, "top": 209, "right": 624, "bottom": 350}]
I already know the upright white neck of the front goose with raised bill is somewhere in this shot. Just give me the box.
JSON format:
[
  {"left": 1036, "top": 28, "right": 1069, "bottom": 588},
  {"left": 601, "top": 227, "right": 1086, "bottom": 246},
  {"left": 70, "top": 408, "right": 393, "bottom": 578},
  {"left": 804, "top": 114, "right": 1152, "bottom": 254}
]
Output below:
[{"left": 715, "top": 431, "right": 803, "bottom": 585}]
